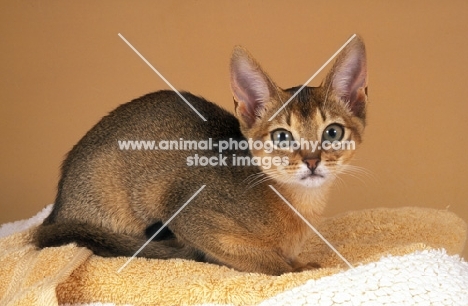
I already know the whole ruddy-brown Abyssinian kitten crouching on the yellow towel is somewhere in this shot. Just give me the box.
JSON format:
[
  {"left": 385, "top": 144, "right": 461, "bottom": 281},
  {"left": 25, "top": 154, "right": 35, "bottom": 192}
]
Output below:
[{"left": 35, "top": 37, "right": 367, "bottom": 275}]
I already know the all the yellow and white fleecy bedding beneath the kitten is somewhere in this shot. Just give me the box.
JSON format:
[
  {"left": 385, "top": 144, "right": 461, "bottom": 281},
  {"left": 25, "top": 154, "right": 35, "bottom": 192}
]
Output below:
[{"left": 0, "top": 206, "right": 468, "bottom": 306}]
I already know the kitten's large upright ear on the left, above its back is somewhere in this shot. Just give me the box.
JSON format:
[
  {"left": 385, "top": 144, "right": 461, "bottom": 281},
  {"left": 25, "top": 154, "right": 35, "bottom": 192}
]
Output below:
[{"left": 230, "top": 46, "right": 276, "bottom": 128}]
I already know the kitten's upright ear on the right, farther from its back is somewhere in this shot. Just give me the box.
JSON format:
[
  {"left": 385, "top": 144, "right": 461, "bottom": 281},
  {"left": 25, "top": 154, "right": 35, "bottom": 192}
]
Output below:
[{"left": 324, "top": 36, "right": 367, "bottom": 119}]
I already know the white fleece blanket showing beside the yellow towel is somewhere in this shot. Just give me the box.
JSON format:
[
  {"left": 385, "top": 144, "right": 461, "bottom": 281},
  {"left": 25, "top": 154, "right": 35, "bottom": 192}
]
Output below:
[{"left": 0, "top": 205, "right": 468, "bottom": 306}]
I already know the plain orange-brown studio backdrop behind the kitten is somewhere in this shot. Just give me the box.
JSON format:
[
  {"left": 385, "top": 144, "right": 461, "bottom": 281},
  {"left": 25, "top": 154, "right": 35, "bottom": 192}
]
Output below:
[{"left": 0, "top": 1, "right": 468, "bottom": 257}]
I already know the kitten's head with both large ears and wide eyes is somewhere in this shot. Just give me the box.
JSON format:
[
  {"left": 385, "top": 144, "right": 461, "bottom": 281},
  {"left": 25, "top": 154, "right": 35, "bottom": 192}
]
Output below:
[{"left": 231, "top": 37, "right": 367, "bottom": 188}]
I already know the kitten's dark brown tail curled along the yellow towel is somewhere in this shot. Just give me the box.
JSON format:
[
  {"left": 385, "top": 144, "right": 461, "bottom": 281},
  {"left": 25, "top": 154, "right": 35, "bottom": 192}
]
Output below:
[{"left": 34, "top": 222, "right": 204, "bottom": 261}]
